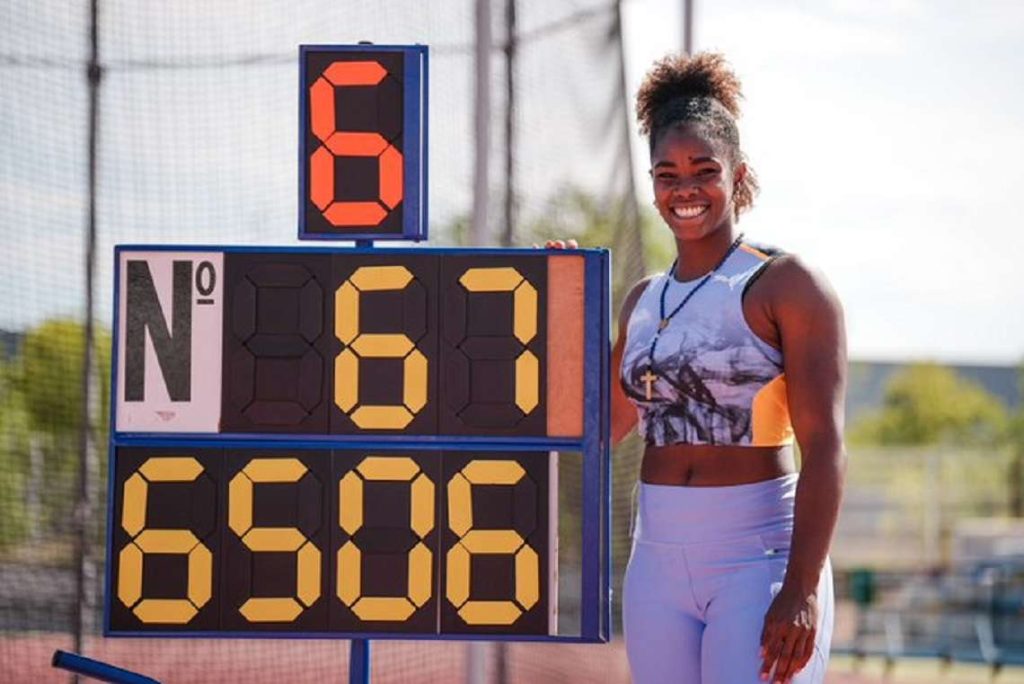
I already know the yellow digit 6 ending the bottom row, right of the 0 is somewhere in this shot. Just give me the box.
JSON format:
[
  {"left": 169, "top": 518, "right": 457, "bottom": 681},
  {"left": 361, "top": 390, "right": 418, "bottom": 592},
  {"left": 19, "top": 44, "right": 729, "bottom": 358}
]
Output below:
[{"left": 445, "top": 461, "right": 541, "bottom": 625}]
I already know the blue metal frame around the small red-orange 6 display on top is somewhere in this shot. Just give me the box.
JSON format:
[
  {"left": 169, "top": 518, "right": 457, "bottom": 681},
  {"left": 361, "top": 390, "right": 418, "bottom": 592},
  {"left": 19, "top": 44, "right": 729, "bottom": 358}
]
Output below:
[{"left": 298, "top": 44, "right": 429, "bottom": 242}]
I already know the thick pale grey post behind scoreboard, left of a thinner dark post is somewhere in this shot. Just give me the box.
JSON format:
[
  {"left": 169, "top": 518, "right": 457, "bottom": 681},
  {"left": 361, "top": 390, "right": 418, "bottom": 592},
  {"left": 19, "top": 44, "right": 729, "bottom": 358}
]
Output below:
[{"left": 469, "top": 0, "right": 493, "bottom": 247}]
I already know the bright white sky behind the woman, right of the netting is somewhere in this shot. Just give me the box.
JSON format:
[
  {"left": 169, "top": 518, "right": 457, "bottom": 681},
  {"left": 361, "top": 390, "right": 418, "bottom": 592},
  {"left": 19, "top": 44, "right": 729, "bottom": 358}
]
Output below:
[{"left": 624, "top": 0, "right": 1024, "bottom": 365}]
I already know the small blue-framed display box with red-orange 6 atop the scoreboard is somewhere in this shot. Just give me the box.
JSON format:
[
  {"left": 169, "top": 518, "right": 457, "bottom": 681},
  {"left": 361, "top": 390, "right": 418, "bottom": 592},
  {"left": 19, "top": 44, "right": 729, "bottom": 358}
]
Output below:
[{"left": 299, "top": 45, "right": 428, "bottom": 241}]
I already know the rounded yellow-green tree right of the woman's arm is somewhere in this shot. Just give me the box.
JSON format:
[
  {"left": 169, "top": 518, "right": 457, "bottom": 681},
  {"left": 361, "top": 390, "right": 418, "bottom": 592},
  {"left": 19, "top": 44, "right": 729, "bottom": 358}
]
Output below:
[{"left": 850, "top": 364, "right": 1010, "bottom": 445}]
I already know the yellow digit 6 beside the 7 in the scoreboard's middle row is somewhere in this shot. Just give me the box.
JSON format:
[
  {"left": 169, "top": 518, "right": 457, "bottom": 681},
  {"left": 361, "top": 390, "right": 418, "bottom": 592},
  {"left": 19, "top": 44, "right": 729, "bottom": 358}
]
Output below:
[{"left": 334, "top": 266, "right": 427, "bottom": 430}]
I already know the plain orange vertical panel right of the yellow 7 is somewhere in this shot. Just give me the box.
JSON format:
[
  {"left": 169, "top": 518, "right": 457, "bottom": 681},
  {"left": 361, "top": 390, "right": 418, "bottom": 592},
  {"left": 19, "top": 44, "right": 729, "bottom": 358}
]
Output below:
[{"left": 547, "top": 254, "right": 584, "bottom": 437}]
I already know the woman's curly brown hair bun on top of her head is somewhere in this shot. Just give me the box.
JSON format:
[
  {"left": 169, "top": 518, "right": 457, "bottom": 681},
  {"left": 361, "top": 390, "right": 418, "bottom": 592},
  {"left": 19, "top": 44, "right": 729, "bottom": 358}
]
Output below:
[{"left": 637, "top": 52, "right": 742, "bottom": 135}]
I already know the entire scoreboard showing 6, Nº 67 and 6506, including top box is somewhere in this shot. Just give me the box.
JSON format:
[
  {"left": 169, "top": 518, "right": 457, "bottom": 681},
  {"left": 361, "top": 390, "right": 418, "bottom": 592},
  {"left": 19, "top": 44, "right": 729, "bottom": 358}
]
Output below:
[{"left": 104, "top": 45, "right": 610, "bottom": 641}]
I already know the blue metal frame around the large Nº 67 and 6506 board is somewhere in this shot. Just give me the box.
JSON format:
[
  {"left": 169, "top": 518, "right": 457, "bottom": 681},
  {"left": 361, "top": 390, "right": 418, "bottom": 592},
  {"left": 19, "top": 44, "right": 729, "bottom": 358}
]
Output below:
[{"left": 103, "top": 241, "right": 611, "bottom": 643}]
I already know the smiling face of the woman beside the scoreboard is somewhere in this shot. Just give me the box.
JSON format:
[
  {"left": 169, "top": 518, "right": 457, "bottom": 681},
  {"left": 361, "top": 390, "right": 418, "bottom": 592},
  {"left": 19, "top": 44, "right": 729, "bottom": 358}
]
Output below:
[{"left": 650, "top": 126, "right": 746, "bottom": 241}]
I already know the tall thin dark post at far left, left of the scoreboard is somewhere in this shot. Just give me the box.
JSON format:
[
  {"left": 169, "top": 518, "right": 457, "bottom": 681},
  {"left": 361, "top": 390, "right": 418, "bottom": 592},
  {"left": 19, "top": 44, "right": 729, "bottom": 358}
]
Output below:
[{"left": 72, "top": 0, "right": 102, "bottom": 682}]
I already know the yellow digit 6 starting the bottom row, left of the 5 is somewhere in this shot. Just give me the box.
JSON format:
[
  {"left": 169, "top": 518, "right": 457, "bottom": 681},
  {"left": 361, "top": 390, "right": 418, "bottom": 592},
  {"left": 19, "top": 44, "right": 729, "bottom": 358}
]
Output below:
[{"left": 118, "top": 457, "right": 213, "bottom": 625}]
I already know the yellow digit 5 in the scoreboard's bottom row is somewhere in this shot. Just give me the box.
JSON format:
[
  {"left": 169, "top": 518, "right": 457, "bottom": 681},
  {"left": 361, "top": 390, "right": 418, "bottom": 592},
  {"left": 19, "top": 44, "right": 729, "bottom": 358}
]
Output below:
[{"left": 227, "top": 459, "right": 321, "bottom": 623}]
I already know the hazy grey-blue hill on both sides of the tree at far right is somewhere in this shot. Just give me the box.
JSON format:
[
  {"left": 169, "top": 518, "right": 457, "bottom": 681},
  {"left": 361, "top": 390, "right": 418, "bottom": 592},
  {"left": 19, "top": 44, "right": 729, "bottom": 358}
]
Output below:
[{"left": 846, "top": 361, "right": 1022, "bottom": 423}]
